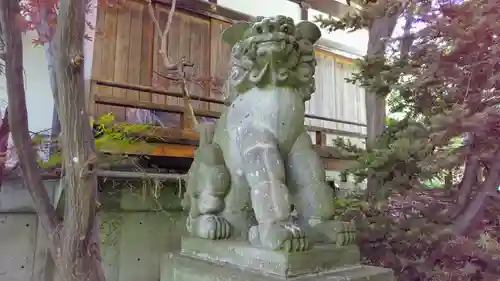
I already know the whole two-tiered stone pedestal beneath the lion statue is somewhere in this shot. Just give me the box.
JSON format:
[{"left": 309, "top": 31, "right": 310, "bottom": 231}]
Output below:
[{"left": 161, "top": 238, "right": 394, "bottom": 281}]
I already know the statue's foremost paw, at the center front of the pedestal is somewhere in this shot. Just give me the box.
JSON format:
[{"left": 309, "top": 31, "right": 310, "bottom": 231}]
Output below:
[{"left": 249, "top": 223, "right": 309, "bottom": 252}]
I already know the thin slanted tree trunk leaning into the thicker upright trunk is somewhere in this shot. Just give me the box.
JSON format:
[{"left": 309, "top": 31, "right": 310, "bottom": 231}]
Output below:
[{"left": 0, "top": 1, "right": 60, "bottom": 257}]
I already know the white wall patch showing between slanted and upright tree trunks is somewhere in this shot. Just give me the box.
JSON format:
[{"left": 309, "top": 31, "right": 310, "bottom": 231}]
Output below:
[{"left": 0, "top": 31, "right": 54, "bottom": 132}]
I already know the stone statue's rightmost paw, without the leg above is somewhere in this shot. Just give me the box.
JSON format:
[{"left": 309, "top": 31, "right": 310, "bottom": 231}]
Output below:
[{"left": 312, "top": 220, "right": 356, "bottom": 246}]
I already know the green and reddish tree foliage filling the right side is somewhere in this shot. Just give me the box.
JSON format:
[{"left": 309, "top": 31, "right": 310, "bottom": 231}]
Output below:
[{"left": 323, "top": 0, "right": 500, "bottom": 281}]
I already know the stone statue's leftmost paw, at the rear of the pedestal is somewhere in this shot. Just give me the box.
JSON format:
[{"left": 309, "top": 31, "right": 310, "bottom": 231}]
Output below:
[{"left": 190, "top": 215, "right": 231, "bottom": 240}]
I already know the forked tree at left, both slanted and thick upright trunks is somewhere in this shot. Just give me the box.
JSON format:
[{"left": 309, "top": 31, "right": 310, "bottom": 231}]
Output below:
[{"left": 0, "top": 0, "right": 105, "bottom": 281}]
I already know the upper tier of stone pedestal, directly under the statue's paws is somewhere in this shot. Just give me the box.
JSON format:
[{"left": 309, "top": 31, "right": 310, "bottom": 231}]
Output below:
[{"left": 181, "top": 237, "right": 360, "bottom": 278}]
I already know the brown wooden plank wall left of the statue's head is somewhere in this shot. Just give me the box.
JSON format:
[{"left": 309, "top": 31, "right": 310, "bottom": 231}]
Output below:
[{"left": 92, "top": 1, "right": 230, "bottom": 127}]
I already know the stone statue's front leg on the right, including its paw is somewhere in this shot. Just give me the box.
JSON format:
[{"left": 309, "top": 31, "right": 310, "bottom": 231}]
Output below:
[{"left": 286, "top": 132, "right": 355, "bottom": 245}]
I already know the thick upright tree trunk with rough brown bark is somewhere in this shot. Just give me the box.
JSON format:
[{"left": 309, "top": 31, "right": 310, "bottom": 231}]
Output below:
[{"left": 53, "top": 0, "right": 104, "bottom": 281}]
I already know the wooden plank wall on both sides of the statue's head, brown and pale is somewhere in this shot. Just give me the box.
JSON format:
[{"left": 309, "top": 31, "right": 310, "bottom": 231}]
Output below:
[{"left": 92, "top": 1, "right": 366, "bottom": 143}]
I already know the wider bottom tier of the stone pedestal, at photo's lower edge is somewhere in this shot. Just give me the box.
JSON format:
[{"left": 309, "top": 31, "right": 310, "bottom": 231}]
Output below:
[{"left": 160, "top": 253, "right": 394, "bottom": 281}]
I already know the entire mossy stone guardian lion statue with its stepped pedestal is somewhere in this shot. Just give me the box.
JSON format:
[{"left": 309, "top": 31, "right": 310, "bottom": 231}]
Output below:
[{"left": 168, "top": 13, "right": 394, "bottom": 281}]
